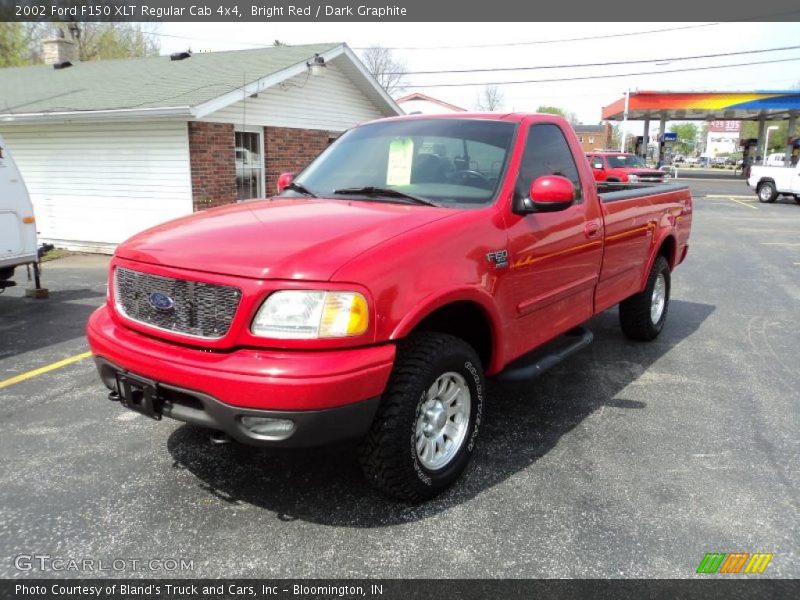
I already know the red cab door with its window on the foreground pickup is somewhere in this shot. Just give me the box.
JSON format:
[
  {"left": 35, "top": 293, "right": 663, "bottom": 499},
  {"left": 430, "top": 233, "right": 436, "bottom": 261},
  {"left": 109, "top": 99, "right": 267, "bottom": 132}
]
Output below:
[{"left": 504, "top": 123, "right": 603, "bottom": 356}]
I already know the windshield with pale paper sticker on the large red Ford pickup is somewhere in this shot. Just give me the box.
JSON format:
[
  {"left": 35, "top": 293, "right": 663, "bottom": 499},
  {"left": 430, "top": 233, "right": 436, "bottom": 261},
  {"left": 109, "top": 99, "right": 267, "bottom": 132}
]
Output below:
[{"left": 282, "top": 119, "right": 516, "bottom": 207}]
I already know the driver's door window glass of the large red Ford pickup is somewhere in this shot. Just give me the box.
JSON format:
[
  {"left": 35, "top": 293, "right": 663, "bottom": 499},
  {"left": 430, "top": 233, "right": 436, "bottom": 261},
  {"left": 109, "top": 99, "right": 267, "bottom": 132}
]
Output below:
[{"left": 516, "top": 123, "right": 582, "bottom": 203}]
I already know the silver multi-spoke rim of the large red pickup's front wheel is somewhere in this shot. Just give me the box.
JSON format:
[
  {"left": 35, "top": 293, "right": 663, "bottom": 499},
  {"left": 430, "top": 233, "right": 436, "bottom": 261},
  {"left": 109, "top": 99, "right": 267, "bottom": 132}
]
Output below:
[{"left": 415, "top": 371, "right": 471, "bottom": 471}]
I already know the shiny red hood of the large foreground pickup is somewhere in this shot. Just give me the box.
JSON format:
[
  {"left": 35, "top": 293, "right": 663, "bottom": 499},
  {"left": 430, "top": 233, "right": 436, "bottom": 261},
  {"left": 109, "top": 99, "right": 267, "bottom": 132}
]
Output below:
[{"left": 116, "top": 198, "right": 457, "bottom": 281}]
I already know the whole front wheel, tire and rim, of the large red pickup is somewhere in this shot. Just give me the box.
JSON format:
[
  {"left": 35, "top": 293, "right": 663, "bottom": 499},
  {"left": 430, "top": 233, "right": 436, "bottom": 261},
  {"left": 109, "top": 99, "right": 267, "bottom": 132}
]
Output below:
[{"left": 359, "top": 332, "right": 486, "bottom": 502}]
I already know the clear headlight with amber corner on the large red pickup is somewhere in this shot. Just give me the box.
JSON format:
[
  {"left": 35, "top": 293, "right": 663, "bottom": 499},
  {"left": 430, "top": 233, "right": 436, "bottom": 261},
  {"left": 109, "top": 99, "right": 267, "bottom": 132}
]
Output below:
[{"left": 250, "top": 290, "right": 369, "bottom": 339}]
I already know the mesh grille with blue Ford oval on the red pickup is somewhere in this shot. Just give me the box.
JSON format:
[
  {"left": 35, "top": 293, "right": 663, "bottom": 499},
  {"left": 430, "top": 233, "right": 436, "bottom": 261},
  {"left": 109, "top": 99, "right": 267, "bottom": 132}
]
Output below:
[{"left": 114, "top": 267, "right": 242, "bottom": 339}]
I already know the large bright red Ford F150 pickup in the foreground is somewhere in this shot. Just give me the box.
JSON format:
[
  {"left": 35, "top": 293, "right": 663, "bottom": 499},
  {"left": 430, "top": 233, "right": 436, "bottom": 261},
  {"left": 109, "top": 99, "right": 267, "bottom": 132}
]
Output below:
[{"left": 87, "top": 114, "right": 692, "bottom": 501}]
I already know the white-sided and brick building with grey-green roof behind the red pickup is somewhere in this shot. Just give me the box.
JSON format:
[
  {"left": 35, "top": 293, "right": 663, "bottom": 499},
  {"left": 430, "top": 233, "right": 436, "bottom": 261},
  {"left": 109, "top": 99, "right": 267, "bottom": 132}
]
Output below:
[{"left": 0, "top": 39, "right": 402, "bottom": 252}]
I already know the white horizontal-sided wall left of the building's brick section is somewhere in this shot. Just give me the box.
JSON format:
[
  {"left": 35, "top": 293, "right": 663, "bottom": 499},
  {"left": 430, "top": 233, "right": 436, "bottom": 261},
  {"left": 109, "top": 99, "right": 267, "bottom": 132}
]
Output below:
[{"left": 2, "top": 122, "right": 192, "bottom": 252}]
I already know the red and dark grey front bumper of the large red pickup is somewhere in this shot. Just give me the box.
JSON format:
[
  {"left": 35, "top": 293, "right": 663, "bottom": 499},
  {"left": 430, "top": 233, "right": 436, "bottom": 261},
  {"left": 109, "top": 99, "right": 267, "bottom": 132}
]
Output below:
[{"left": 87, "top": 306, "right": 395, "bottom": 447}]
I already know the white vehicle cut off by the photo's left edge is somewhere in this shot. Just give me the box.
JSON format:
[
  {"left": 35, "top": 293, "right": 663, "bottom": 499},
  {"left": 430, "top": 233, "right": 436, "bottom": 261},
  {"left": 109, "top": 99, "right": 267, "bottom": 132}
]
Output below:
[{"left": 0, "top": 137, "right": 39, "bottom": 292}]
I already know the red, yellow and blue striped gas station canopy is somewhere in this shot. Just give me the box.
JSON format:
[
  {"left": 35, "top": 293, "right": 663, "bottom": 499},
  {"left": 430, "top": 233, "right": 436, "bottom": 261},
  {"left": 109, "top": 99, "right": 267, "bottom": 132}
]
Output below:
[{"left": 603, "top": 90, "right": 800, "bottom": 121}]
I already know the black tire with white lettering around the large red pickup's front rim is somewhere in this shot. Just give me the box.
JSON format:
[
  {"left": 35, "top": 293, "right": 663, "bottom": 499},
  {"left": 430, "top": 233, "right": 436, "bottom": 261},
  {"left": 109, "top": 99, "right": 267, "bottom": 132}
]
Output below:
[{"left": 359, "top": 332, "right": 486, "bottom": 502}]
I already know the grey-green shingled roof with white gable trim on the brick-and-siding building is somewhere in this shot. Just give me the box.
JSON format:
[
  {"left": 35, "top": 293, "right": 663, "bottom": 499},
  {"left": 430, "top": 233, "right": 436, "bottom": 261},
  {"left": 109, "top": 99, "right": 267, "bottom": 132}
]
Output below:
[{"left": 0, "top": 43, "right": 402, "bottom": 121}]
